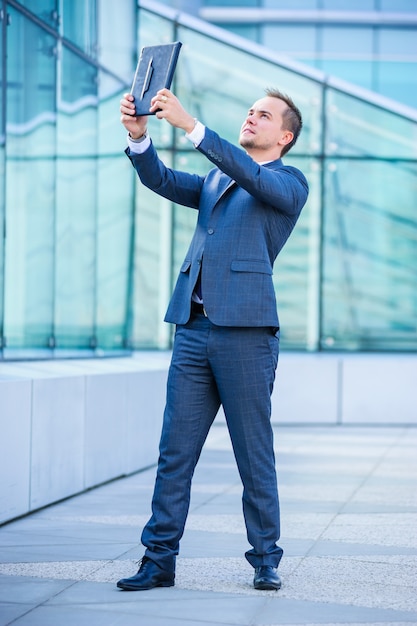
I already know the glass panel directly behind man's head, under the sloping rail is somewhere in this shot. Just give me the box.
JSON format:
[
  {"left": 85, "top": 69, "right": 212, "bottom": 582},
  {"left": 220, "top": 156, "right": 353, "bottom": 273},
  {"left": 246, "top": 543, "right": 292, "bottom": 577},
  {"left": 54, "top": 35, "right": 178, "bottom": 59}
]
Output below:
[{"left": 177, "top": 28, "right": 321, "bottom": 154}]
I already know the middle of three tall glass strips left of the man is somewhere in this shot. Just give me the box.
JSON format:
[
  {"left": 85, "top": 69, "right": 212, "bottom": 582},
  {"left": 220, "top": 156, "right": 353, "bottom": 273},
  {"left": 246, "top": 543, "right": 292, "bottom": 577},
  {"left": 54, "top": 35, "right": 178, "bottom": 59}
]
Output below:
[{"left": 55, "top": 47, "right": 97, "bottom": 349}]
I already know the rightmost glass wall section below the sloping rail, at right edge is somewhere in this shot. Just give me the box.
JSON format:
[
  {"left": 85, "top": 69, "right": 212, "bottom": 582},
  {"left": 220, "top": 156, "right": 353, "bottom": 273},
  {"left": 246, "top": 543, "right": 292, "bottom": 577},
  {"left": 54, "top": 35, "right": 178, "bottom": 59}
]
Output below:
[{"left": 321, "top": 89, "right": 417, "bottom": 350}]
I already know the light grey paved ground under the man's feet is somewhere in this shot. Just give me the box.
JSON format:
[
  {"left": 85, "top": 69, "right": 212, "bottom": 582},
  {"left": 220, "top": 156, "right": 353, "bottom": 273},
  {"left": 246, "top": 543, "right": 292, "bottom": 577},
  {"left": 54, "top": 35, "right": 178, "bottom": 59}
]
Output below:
[{"left": 0, "top": 423, "right": 417, "bottom": 626}]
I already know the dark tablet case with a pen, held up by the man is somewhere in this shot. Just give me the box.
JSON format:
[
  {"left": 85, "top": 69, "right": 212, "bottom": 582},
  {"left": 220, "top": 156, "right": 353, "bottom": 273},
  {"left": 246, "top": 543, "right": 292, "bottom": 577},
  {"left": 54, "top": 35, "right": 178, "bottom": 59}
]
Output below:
[{"left": 131, "top": 41, "right": 182, "bottom": 115}]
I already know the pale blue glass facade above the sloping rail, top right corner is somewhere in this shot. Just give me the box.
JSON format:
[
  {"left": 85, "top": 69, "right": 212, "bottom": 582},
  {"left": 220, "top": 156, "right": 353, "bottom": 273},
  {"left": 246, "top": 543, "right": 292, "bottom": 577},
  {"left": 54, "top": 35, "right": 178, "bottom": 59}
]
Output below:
[{"left": 169, "top": 0, "right": 417, "bottom": 108}]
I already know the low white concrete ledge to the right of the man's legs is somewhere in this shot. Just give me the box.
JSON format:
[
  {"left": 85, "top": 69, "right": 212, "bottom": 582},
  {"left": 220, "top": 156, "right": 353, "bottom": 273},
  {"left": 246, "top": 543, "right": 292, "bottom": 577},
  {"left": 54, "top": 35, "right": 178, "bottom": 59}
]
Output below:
[{"left": 272, "top": 352, "right": 417, "bottom": 425}]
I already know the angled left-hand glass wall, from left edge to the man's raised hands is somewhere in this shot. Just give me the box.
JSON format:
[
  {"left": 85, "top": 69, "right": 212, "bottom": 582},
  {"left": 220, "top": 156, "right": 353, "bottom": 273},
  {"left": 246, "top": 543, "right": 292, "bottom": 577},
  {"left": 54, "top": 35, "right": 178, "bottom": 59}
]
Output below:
[{"left": 0, "top": 0, "right": 136, "bottom": 358}]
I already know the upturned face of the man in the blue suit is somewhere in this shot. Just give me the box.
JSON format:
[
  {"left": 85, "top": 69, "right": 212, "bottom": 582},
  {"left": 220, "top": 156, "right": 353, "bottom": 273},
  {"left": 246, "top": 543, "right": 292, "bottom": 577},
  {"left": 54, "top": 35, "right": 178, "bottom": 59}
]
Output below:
[{"left": 239, "top": 96, "right": 288, "bottom": 151}]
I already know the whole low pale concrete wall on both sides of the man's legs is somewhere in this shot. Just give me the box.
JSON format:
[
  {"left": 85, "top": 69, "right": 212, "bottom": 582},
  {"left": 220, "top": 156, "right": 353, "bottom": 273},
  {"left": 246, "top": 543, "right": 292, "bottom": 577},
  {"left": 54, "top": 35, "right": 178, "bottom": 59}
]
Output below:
[{"left": 0, "top": 352, "right": 417, "bottom": 523}]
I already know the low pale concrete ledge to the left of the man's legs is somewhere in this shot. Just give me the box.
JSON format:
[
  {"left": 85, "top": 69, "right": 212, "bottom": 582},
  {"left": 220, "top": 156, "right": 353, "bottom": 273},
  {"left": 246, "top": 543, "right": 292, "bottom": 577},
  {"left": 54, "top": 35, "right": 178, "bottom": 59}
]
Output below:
[{"left": 0, "top": 353, "right": 171, "bottom": 523}]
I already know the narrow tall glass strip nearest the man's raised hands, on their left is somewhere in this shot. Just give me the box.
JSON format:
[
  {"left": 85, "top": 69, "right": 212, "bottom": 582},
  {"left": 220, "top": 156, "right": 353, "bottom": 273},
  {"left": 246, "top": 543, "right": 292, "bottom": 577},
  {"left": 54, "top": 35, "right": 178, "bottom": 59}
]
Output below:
[{"left": 96, "top": 74, "right": 134, "bottom": 350}]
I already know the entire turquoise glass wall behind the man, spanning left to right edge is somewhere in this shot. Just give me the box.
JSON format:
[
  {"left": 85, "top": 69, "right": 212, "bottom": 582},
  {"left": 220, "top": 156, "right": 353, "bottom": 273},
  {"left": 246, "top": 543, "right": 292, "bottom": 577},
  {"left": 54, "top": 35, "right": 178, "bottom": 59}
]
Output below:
[{"left": 0, "top": 0, "right": 417, "bottom": 359}]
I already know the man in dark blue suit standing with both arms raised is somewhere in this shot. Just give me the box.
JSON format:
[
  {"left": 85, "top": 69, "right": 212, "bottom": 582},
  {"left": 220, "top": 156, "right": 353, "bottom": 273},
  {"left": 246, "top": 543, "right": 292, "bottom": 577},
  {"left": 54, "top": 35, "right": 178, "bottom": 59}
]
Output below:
[{"left": 117, "top": 89, "right": 308, "bottom": 591}]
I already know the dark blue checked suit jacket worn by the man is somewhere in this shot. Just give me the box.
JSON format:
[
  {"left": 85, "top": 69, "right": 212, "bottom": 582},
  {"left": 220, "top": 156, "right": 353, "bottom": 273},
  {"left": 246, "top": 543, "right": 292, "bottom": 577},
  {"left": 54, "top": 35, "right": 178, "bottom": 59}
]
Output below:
[{"left": 126, "top": 128, "right": 308, "bottom": 327}]
